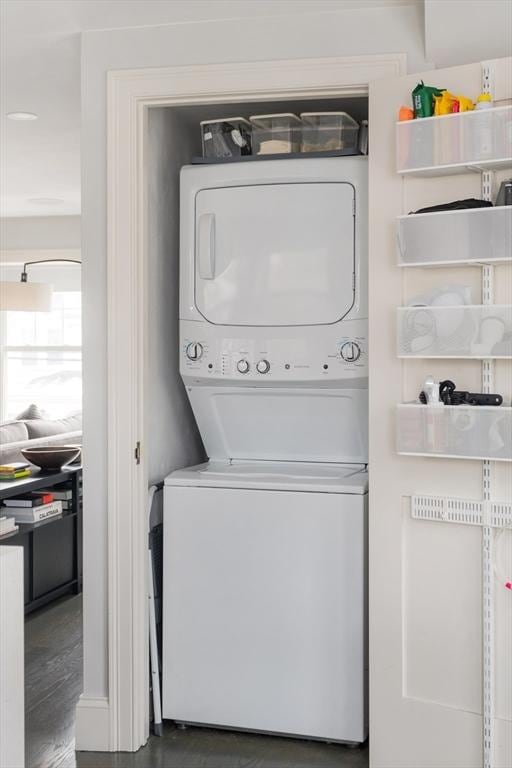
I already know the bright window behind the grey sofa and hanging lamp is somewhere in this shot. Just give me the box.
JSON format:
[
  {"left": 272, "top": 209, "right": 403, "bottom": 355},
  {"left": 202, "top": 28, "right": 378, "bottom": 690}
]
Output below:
[{"left": 1, "top": 290, "right": 82, "bottom": 420}]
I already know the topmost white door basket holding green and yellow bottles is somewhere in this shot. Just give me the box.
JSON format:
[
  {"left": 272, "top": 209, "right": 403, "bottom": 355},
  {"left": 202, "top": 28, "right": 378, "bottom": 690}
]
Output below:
[{"left": 396, "top": 106, "right": 512, "bottom": 176}]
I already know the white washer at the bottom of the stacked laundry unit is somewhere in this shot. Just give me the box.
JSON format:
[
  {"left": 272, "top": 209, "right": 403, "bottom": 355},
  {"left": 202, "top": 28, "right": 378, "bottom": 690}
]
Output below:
[{"left": 163, "top": 462, "right": 368, "bottom": 742}]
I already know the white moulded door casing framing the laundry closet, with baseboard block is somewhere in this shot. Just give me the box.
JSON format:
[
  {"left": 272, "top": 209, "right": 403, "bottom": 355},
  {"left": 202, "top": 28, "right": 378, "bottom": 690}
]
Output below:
[{"left": 82, "top": 54, "right": 405, "bottom": 751}]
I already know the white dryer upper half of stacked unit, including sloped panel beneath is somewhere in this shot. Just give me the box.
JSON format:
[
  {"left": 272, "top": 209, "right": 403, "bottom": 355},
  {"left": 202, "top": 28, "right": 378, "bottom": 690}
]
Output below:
[{"left": 180, "top": 157, "right": 368, "bottom": 463}]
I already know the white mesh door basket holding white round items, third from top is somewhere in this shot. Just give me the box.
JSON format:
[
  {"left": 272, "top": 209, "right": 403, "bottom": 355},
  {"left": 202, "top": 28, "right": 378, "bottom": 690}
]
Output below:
[{"left": 397, "top": 304, "right": 512, "bottom": 359}]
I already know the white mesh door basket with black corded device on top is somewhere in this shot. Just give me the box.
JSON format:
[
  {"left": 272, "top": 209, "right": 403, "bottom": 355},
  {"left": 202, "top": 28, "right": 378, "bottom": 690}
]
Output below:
[{"left": 396, "top": 403, "right": 512, "bottom": 461}]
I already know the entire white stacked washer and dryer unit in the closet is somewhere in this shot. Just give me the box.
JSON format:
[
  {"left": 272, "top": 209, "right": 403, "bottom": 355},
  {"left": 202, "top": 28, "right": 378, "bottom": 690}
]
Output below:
[{"left": 163, "top": 157, "right": 368, "bottom": 742}]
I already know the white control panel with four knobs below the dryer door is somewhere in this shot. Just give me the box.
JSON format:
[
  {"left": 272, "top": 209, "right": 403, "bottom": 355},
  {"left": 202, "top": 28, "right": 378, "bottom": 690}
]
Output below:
[{"left": 180, "top": 320, "right": 368, "bottom": 385}]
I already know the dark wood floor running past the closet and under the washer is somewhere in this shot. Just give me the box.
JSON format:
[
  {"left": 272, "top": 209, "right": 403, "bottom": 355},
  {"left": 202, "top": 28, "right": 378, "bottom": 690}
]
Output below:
[{"left": 25, "top": 596, "right": 368, "bottom": 768}]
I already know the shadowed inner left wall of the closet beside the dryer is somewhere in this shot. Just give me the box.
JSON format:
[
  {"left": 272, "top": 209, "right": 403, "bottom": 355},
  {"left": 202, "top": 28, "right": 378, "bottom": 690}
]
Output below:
[{"left": 145, "top": 108, "right": 204, "bottom": 492}]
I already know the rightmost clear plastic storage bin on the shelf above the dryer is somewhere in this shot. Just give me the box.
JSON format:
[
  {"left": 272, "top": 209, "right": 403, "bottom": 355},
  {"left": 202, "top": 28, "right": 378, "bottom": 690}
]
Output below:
[{"left": 300, "top": 112, "right": 359, "bottom": 152}]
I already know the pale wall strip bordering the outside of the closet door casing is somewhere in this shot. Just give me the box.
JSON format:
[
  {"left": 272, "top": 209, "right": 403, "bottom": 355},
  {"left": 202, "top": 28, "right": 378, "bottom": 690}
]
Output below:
[{"left": 82, "top": 2, "right": 429, "bottom": 697}]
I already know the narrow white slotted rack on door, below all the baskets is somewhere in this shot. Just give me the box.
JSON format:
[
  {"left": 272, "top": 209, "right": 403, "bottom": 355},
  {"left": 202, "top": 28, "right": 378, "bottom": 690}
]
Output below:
[{"left": 411, "top": 494, "right": 512, "bottom": 528}]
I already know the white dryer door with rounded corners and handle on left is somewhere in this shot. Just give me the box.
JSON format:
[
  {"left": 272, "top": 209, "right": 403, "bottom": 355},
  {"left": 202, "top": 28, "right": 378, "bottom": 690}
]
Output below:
[{"left": 195, "top": 182, "right": 355, "bottom": 326}]
